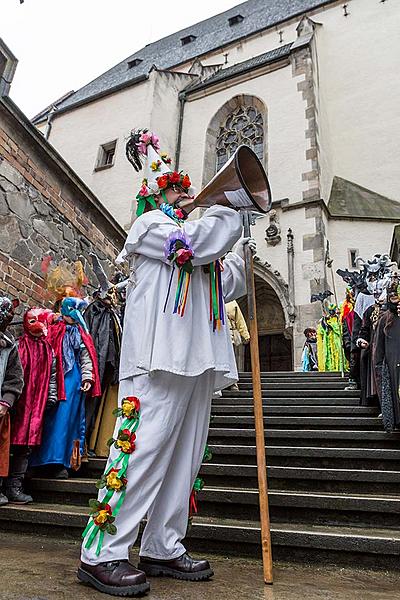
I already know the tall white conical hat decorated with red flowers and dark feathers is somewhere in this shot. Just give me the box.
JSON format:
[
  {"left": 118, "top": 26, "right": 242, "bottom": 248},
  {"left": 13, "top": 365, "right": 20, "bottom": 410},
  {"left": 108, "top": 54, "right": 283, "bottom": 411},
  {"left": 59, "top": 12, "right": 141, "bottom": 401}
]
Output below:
[{"left": 126, "top": 129, "right": 192, "bottom": 216}]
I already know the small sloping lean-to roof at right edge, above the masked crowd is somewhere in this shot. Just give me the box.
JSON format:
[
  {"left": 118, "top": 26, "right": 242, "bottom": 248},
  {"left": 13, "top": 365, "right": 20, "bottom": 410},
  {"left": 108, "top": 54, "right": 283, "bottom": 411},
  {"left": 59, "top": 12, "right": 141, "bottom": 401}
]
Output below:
[{"left": 328, "top": 177, "right": 400, "bottom": 221}]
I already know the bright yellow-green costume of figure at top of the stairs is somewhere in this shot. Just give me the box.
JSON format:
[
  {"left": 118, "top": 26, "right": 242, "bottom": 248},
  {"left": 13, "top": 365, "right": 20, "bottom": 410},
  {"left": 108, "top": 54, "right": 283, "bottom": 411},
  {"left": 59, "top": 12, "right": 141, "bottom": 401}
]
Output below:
[{"left": 317, "top": 304, "right": 345, "bottom": 371}]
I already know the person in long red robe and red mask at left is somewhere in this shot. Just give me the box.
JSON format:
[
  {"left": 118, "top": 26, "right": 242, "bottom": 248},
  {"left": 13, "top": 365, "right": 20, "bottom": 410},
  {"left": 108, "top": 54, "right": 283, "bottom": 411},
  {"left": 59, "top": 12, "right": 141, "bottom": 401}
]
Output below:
[{"left": 6, "top": 308, "right": 57, "bottom": 504}]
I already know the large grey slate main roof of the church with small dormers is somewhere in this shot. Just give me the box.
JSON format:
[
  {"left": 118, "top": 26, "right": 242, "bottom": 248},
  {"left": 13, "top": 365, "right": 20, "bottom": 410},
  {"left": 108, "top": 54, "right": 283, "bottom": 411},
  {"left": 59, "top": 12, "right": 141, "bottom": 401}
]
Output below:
[{"left": 34, "top": 0, "right": 335, "bottom": 122}]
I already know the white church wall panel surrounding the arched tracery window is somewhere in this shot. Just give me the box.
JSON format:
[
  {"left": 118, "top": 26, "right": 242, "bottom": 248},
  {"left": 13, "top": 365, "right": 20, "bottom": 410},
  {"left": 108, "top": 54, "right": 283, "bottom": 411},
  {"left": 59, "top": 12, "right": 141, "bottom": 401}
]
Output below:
[{"left": 181, "top": 66, "right": 308, "bottom": 202}]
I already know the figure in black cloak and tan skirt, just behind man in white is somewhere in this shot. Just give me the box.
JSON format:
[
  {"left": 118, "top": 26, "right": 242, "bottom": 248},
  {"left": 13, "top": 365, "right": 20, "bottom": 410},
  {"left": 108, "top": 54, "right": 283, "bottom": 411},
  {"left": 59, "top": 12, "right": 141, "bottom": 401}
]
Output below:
[{"left": 84, "top": 255, "right": 123, "bottom": 456}]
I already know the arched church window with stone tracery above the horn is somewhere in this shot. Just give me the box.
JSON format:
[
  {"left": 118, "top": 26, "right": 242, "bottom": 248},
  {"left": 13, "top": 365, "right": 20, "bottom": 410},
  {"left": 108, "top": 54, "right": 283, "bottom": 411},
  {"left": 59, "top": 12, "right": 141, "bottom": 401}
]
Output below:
[{"left": 216, "top": 106, "right": 264, "bottom": 171}]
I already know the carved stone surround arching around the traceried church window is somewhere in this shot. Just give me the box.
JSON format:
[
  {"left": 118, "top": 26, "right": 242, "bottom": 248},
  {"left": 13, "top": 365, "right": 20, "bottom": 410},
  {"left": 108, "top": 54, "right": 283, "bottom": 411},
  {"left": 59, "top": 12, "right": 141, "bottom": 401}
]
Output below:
[{"left": 202, "top": 94, "right": 268, "bottom": 187}]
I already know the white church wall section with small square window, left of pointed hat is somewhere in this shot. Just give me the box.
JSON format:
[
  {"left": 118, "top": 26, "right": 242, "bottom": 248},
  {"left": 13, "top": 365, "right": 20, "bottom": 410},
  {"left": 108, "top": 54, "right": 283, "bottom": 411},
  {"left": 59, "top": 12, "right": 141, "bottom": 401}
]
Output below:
[{"left": 49, "top": 80, "right": 153, "bottom": 226}]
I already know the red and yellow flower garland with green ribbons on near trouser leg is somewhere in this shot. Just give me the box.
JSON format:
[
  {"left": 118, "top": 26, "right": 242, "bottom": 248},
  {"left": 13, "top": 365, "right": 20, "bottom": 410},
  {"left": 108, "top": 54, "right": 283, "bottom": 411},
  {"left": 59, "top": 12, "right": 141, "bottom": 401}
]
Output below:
[{"left": 82, "top": 396, "right": 140, "bottom": 556}]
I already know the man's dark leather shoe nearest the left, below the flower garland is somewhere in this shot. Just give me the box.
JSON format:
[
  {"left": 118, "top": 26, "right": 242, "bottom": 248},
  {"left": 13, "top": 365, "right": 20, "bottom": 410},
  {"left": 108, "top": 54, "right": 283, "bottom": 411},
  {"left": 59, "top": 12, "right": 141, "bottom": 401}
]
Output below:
[{"left": 78, "top": 560, "right": 150, "bottom": 597}]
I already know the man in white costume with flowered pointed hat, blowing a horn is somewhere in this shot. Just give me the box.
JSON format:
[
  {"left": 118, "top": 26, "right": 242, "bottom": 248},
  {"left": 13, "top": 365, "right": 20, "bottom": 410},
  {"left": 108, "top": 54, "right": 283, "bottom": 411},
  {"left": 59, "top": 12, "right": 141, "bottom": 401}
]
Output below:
[{"left": 78, "top": 130, "right": 254, "bottom": 596}]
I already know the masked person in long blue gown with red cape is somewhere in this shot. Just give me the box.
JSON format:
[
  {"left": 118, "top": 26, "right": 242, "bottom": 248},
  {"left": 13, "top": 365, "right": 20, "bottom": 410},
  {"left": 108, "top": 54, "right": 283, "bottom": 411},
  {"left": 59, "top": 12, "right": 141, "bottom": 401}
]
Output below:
[{"left": 30, "top": 297, "right": 101, "bottom": 478}]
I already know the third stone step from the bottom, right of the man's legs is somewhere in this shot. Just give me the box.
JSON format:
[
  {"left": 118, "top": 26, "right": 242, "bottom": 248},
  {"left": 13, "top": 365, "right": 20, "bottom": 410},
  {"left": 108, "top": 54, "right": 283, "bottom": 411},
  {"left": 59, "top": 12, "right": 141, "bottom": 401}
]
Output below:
[{"left": 200, "top": 463, "right": 400, "bottom": 494}]
